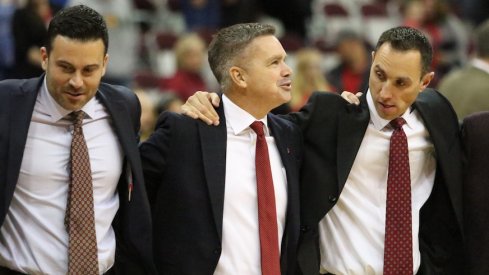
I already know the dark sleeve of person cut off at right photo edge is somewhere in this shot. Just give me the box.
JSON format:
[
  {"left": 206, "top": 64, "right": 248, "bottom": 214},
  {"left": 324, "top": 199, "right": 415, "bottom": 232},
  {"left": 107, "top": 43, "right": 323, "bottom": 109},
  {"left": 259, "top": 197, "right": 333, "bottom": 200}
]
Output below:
[{"left": 462, "top": 112, "right": 489, "bottom": 275}]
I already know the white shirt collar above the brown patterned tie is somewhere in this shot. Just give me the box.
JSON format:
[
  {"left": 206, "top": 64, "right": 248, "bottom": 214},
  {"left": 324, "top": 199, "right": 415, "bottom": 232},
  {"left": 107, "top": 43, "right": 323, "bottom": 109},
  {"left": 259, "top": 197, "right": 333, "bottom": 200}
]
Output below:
[{"left": 39, "top": 77, "right": 95, "bottom": 122}]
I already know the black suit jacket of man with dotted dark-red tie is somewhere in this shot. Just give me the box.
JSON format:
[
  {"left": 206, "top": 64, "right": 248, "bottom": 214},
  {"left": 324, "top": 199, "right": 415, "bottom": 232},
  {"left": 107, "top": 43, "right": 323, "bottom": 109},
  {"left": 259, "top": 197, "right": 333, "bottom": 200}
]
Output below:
[{"left": 289, "top": 89, "right": 462, "bottom": 275}]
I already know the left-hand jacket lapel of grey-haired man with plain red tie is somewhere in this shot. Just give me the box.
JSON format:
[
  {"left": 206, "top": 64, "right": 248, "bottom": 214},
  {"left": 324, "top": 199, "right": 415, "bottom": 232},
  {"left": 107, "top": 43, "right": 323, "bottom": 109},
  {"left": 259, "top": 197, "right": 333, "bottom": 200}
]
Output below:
[{"left": 199, "top": 104, "right": 227, "bottom": 239}]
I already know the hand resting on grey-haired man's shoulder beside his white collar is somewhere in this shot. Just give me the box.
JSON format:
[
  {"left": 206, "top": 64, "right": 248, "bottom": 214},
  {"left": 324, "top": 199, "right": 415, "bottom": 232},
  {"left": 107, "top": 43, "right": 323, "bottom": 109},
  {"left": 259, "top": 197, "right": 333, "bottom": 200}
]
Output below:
[{"left": 182, "top": 91, "right": 221, "bottom": 126}]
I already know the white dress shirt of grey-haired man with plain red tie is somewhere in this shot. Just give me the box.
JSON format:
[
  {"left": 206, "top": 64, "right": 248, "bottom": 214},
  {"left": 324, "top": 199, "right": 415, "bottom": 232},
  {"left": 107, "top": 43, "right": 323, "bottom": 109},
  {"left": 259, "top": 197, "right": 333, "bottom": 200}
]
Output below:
[{"left": 214, "top": 95, "right": 287, "bottom": 275}]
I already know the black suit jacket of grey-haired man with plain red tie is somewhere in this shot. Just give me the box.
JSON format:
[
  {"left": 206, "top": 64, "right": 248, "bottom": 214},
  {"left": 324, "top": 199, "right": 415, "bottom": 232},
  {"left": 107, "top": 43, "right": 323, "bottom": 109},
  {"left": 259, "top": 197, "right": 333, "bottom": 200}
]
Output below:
[{"left": 140, "top": 103, "right": 302, "bottom": 275}]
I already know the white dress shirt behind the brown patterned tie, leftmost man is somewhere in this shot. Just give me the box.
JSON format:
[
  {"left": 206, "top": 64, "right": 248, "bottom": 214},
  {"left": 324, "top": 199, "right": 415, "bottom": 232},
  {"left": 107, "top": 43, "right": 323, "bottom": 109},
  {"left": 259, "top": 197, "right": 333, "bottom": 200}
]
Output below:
[{"left": 0, "top": 80, "right": 122, "bottom": 274}]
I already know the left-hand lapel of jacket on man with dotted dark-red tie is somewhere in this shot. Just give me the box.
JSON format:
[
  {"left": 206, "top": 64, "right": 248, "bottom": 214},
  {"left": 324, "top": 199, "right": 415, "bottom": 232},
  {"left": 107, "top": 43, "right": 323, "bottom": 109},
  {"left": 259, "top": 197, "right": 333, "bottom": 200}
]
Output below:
[{"left": 336, "top": 93, "right": 370, "bottom": 193}]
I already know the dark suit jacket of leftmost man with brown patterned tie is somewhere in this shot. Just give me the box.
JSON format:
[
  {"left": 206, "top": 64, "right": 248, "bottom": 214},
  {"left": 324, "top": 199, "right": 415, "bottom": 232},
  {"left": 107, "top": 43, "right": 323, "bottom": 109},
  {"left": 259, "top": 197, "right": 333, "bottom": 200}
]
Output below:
[{"left": 0, "top": 76, "right": 155, "bottom": 274}]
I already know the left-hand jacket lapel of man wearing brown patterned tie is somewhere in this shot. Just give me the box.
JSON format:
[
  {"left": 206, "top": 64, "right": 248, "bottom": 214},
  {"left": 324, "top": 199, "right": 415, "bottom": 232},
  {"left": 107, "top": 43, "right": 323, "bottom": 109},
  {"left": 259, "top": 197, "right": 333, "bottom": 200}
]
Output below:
[{"left": 3, "top": 78, "right": 44, "bottom": 209}]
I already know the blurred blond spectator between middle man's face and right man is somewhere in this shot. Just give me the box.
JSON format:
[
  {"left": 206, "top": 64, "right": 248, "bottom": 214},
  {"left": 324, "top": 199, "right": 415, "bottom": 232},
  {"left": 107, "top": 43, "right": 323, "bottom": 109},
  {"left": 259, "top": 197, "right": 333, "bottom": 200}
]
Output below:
[{"left": 289, "top": 48, "right": 331, "bottom": 111}]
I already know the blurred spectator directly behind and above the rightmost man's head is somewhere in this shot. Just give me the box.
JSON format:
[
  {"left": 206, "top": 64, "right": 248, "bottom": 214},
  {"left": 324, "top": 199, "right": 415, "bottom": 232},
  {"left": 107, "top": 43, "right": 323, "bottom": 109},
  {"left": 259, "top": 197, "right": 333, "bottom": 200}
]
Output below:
[{"left": 402, "top": 0, "right": 469, "bottom": 86}]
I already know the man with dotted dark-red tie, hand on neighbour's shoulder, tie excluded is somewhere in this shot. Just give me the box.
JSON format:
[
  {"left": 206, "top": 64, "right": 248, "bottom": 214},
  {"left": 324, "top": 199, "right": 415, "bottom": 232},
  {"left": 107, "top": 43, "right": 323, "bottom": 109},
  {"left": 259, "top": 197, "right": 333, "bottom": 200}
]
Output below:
[{"left": 185, "top": 27, "right": 463, "bottom": 275}]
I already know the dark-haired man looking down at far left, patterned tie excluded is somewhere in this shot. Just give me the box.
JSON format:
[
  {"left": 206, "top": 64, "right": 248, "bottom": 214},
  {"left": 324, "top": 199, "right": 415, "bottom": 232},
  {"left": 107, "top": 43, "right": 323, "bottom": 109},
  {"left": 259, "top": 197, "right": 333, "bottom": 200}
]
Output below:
[{"left": 0, "top": 6, "right": 156, "bottom": 274}]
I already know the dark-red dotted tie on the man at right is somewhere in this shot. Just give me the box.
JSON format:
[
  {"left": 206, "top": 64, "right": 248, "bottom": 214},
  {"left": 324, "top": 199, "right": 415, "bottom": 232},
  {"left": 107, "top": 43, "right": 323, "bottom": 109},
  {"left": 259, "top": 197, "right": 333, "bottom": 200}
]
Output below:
[{"left": 384, "top": 118, "right": 413, "bottom": 275}]
